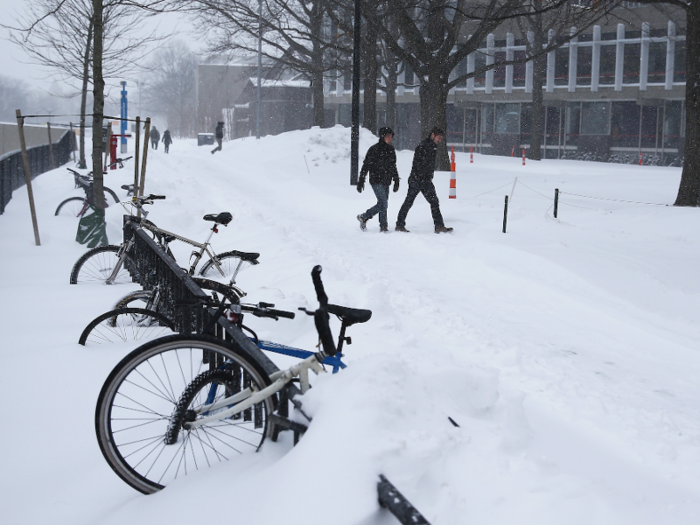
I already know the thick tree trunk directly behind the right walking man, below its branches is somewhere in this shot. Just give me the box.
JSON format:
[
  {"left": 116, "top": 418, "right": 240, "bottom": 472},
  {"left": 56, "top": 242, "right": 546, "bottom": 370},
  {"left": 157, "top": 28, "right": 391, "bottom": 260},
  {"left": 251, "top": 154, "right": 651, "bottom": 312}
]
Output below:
[{"left": 420, "top": 72, "right": 450, "bottom": 171}]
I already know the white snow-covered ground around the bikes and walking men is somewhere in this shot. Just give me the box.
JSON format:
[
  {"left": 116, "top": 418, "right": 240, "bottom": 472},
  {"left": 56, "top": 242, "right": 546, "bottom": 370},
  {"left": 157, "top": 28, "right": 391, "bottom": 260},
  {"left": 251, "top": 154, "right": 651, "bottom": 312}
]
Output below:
[{"left": 0, "top": 127, "right": 700, "bottom": 525}]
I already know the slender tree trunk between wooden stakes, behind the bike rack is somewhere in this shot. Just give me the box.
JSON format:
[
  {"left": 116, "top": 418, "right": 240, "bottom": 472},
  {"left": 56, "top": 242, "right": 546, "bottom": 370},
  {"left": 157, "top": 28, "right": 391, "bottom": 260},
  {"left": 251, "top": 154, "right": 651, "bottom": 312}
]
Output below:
[{"left": 92, "top": 0, "right": 105, "bottom": 210}]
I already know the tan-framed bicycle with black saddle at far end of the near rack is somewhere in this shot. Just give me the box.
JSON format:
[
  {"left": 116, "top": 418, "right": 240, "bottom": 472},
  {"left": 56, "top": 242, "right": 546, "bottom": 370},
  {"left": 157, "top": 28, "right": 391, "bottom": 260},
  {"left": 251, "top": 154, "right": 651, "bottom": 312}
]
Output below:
[{"left": 70, "top": 194, "right": 260, "bottom": 285}]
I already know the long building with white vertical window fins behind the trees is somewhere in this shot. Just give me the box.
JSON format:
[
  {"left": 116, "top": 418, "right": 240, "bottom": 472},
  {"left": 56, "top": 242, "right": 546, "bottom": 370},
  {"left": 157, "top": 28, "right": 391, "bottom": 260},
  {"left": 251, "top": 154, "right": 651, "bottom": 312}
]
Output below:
[{"left": 326, "top": 2, "right": 686, "bottom": 165}]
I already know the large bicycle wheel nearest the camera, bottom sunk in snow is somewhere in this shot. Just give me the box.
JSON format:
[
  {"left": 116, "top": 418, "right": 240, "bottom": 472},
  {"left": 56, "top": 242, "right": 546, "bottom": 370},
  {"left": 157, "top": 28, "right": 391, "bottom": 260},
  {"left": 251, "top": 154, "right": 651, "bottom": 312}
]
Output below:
[{"left": 95, "top": 335, "right": 276, "bottom": 494}]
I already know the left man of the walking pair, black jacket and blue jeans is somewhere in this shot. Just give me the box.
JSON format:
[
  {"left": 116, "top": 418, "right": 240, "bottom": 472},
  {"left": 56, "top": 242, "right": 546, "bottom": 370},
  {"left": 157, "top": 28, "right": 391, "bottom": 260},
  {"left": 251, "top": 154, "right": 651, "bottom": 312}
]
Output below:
[{"left": 357, "top": 127, "right": 401, "bottom": 232}]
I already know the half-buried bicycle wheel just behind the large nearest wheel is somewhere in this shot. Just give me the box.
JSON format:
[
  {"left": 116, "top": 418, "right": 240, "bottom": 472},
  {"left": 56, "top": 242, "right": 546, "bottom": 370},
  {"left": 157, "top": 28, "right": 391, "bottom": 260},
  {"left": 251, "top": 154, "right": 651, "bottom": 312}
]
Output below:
[{"left": 78, "top": 308, "right": 175, "bottom": 346}]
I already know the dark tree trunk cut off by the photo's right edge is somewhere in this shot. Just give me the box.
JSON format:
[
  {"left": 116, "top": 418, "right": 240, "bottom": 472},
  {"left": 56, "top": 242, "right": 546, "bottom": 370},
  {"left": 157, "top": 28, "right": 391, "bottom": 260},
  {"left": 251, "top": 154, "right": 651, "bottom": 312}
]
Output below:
[{"left": 674, "top": 2, "right": 700, "bottom": 206}]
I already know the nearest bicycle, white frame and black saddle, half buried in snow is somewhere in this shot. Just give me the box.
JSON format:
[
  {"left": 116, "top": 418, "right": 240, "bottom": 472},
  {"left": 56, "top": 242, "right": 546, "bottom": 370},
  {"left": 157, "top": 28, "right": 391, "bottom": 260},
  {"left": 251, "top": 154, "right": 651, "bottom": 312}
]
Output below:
[{"left": 95, "top": 266, "right": 372, "bottom": 494}]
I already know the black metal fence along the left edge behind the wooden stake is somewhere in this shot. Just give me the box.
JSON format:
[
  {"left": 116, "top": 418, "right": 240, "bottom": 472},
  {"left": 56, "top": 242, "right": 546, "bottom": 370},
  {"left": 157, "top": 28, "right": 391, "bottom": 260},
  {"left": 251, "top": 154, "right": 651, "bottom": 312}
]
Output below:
[{"left": 0, "top": 130, "right": 75, "bottom": 214}]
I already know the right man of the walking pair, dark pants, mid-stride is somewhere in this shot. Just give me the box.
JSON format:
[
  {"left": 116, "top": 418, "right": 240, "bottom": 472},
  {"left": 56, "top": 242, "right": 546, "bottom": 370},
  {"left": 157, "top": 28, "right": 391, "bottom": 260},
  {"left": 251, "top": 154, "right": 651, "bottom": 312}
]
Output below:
[{"left": 396, "top": 127, "right": 452, "bottom": 233}]
